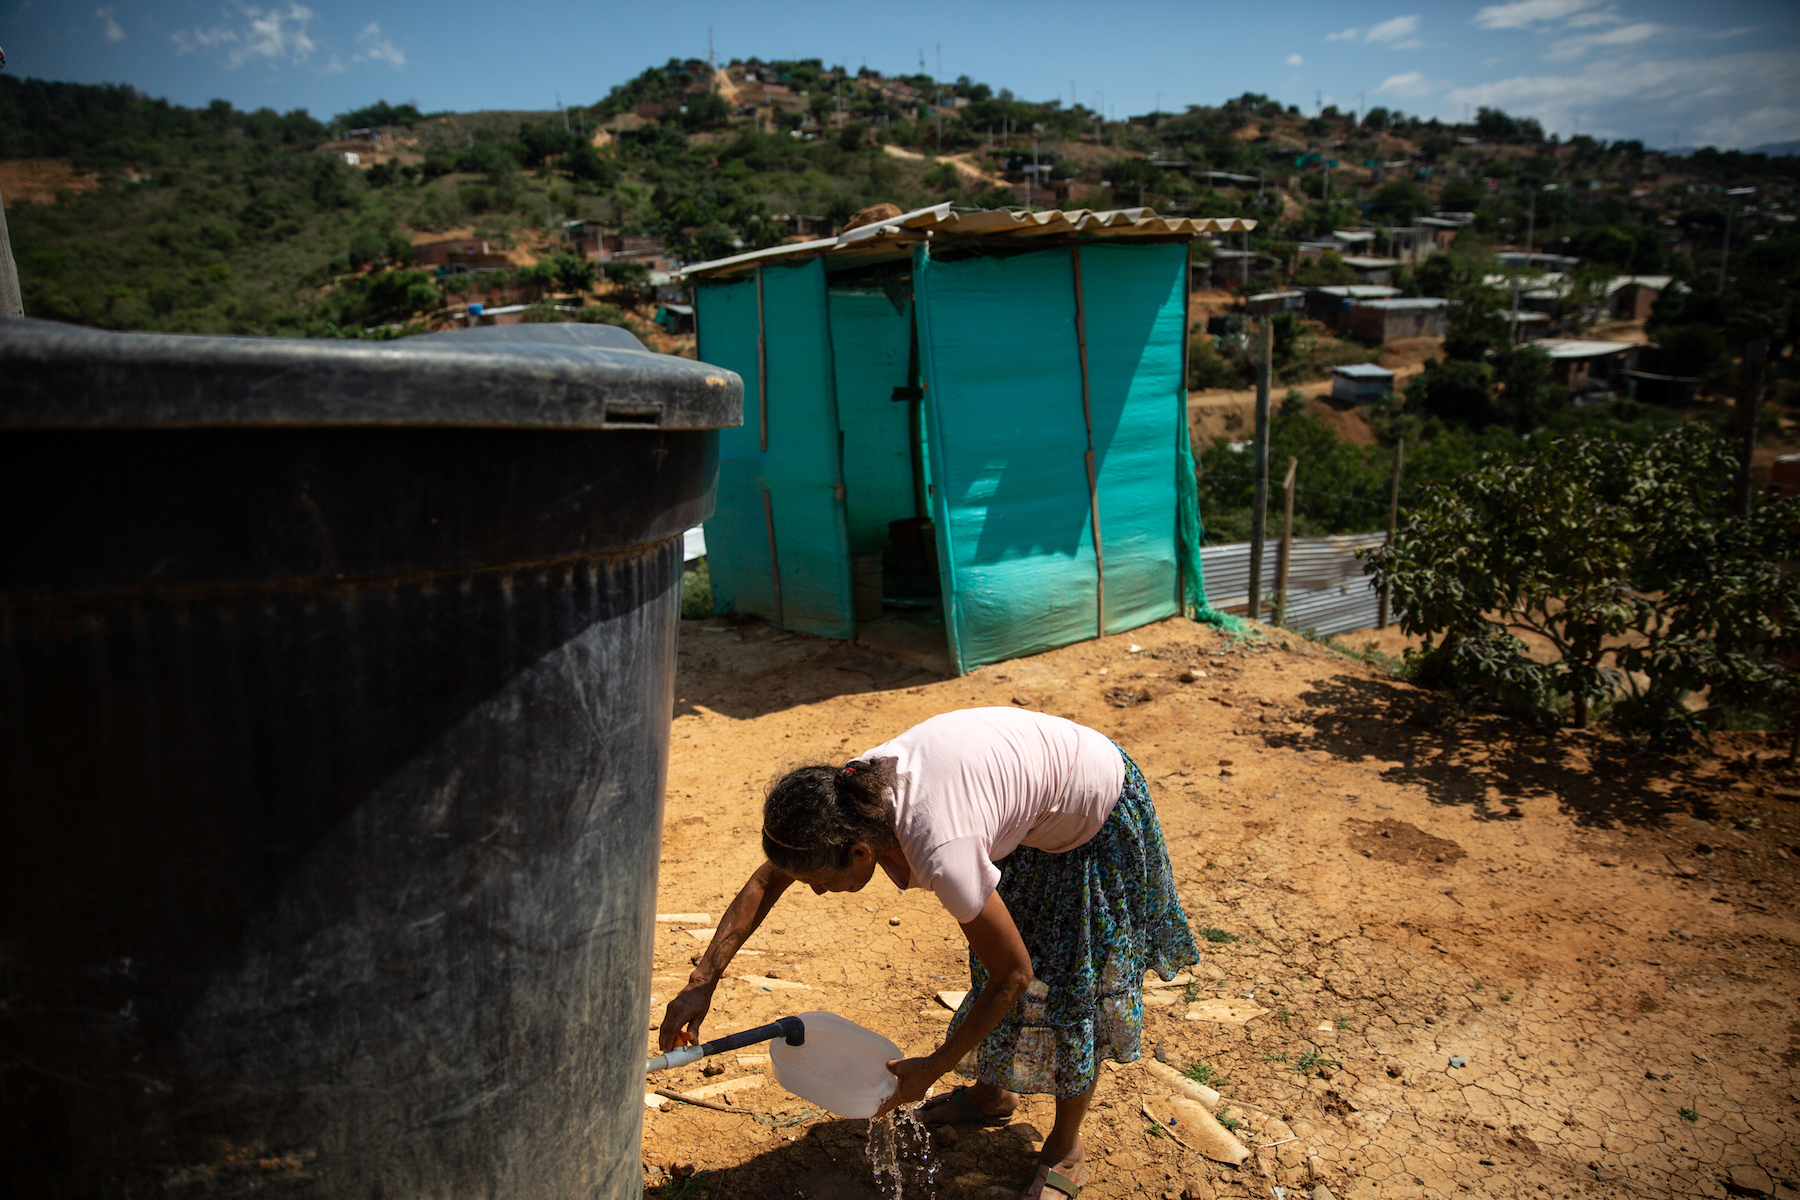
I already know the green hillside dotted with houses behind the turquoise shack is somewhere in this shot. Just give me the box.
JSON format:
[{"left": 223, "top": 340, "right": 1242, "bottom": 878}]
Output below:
[{"left": 0, "top": 59, "right": 1800, "bottom": 540}]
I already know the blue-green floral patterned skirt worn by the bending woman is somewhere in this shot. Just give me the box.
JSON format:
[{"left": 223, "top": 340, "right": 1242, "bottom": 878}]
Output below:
[{"left": 950, "top": 750, "right": 1201, "bottom": 1097}]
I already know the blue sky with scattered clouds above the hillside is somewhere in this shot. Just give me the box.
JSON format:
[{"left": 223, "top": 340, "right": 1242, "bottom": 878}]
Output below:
[{"left": 0, "top": 0, "right": 1800, "bottom": 146}]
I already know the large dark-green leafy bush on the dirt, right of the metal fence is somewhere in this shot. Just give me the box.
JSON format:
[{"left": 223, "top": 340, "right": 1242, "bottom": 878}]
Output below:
[{"left": 1368, "top": 425, "right": 1800, "bottom": 741}]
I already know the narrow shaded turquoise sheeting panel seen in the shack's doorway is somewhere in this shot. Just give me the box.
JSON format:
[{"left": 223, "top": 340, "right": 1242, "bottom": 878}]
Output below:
[{"left": 830, "top": 290, "right": 914, "bottom": 551}]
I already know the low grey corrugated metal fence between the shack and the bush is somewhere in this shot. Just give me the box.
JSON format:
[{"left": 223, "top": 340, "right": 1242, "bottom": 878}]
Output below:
[{"left": 1201, "top": 533, "right": 1391, "bottom": 637}]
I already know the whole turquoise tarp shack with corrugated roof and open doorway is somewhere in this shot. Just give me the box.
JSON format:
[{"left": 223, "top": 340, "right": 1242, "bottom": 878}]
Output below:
[{"left": 684, "top": 205, "right": 1255, "bottom": 673}]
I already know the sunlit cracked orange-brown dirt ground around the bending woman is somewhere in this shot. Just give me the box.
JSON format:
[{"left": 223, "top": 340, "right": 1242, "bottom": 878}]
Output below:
[{"left": 644, "top": 621, "right": 1800, "bottom": 1200}]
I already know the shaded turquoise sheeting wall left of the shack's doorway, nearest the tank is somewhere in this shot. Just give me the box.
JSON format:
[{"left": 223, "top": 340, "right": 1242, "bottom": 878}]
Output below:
[{"left": 695, "top": 261, "right": 855, "bottom": 639}]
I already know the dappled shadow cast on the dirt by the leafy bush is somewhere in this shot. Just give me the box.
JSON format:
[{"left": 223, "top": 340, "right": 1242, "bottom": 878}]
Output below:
[{"left": 1269, "top": 675, "right": 1715, "bottom": 828}]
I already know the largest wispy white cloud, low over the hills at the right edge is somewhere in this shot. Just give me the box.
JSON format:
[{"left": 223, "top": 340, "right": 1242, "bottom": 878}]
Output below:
[{"left": 1444, "top": 49, "right": 1800, "bottom": 148}]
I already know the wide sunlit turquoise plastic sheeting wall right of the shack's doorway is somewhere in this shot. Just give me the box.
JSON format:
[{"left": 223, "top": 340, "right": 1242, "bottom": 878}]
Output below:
[{"left": 913, "top": 245, "right": 1186, "bottom": 669}]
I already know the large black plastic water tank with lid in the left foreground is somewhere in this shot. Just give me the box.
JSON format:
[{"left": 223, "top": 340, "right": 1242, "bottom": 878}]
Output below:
[{"left": 0, "top": 320, "right": 743, "bottom": 1198}]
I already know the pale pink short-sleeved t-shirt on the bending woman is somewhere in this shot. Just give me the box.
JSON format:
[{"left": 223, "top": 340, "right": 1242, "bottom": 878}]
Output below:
[{"left": 857, "top": 709, "right": 1125, "bottom": 923}]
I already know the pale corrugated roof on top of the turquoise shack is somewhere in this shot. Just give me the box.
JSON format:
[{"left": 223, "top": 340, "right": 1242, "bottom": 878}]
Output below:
[{"left": 682, "top": 203, "right": 1256, "bottom": 279}]
